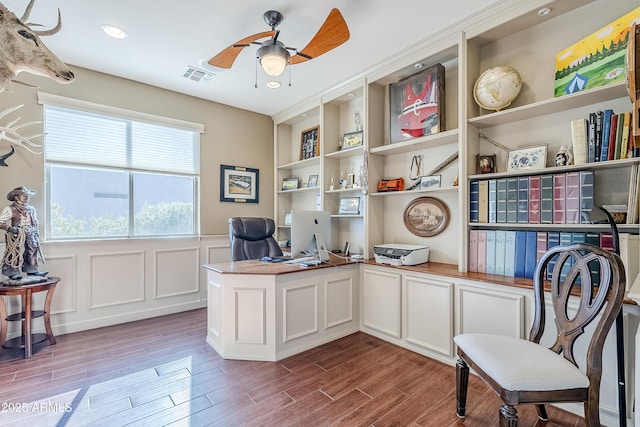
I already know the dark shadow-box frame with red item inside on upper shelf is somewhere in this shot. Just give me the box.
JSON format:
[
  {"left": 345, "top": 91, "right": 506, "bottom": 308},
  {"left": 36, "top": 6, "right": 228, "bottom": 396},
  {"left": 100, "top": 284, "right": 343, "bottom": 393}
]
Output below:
[{"left": 389, "top": 64, "right": 445, "bottom": 144}]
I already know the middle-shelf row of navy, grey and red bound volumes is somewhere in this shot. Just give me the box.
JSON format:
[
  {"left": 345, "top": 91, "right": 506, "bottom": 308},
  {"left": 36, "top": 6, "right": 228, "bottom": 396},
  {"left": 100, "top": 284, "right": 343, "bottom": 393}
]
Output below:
[{"left": 469, "top": 171, "right": 594, "bottom": 224}]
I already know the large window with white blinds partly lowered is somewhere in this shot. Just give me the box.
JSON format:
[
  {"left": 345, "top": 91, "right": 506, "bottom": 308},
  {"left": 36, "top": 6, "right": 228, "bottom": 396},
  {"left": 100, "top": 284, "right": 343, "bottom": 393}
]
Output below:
[{"left": 39, "top": 94, "right": 201, "bottom": 240}]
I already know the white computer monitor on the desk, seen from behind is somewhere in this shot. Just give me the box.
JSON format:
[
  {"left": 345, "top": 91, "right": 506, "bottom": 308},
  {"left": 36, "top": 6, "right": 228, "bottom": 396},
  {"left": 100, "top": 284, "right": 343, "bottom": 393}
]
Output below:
[{"left": 291, "top": 211, "right": 331, "bottom": 259}]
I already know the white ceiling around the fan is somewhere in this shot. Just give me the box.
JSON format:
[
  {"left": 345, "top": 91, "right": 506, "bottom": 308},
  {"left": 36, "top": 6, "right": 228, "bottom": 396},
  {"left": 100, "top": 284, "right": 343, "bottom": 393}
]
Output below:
[{"left": 3, "top": 0, "right": 505, "bottom": 115}]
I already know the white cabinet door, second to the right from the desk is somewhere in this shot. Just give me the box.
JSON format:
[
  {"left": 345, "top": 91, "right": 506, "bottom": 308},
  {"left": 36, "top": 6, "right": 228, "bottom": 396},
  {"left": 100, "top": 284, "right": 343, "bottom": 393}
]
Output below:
[{"left": 403, "top": 276, "right": 453, "bottom": 357}]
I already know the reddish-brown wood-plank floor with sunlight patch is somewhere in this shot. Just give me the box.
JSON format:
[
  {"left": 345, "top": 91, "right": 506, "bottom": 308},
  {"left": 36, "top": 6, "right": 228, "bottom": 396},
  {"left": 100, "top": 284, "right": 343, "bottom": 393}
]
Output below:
[{"left": 0, "top": 309, "right": 583, "bottom": 427}]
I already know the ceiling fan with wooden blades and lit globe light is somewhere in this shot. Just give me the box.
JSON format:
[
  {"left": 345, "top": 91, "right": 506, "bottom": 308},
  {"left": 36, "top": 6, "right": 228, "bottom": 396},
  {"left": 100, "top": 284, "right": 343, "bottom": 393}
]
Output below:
[{"left": 208, "top": 8, "right": 349, "bottom": 77}]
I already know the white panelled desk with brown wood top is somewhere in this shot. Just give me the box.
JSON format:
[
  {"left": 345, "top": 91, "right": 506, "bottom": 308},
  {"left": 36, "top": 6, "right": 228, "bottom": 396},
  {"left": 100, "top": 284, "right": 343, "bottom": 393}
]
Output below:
[{"left": 204, "top": 260, "right": 359, "bottom": 361}]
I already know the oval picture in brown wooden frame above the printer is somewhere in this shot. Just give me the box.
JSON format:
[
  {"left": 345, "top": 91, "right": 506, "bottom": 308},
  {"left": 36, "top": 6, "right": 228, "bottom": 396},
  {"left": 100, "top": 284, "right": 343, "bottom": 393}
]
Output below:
[{"left": 404, "top": 197, "right": 449, "bottom": 237}]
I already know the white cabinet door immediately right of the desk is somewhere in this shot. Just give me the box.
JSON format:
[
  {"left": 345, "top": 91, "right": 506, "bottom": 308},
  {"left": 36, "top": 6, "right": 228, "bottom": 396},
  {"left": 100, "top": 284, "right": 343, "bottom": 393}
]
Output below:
[{"left": 362, "top": 269, "right": 402, "bottom": 338}]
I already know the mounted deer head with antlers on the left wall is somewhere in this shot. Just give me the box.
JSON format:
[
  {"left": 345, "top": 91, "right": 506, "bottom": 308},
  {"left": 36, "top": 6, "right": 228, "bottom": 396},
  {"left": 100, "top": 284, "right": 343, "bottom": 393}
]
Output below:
[{"left": 0, "top": 0, "right": 75, "bottom": 91}]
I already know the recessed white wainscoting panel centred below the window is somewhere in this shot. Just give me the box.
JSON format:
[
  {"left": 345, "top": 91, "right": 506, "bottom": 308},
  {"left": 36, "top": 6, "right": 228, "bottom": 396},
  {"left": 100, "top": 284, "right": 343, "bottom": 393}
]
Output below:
[{"left": 89, "top": 251, "right": 145, "bottom": 308}]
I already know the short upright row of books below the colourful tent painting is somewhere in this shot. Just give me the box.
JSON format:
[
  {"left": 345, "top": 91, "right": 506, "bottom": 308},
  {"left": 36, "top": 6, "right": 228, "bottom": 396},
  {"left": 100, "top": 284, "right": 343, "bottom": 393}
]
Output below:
[{"left": 571, "top": 109, "right": 640, "bottom": 165}]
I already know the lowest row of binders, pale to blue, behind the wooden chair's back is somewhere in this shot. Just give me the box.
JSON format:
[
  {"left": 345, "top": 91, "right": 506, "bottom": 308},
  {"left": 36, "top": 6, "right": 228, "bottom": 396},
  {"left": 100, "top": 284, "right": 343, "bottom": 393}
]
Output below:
[{"left": 468, "top": 230, "right": 639, "bottom": 290}]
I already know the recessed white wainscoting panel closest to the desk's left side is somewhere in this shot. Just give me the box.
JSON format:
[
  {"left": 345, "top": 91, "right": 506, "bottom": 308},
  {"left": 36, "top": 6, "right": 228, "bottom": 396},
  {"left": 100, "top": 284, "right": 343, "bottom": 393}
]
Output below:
[{"left": 154, "top": 247, "right": 200, "bottom": 298}]
